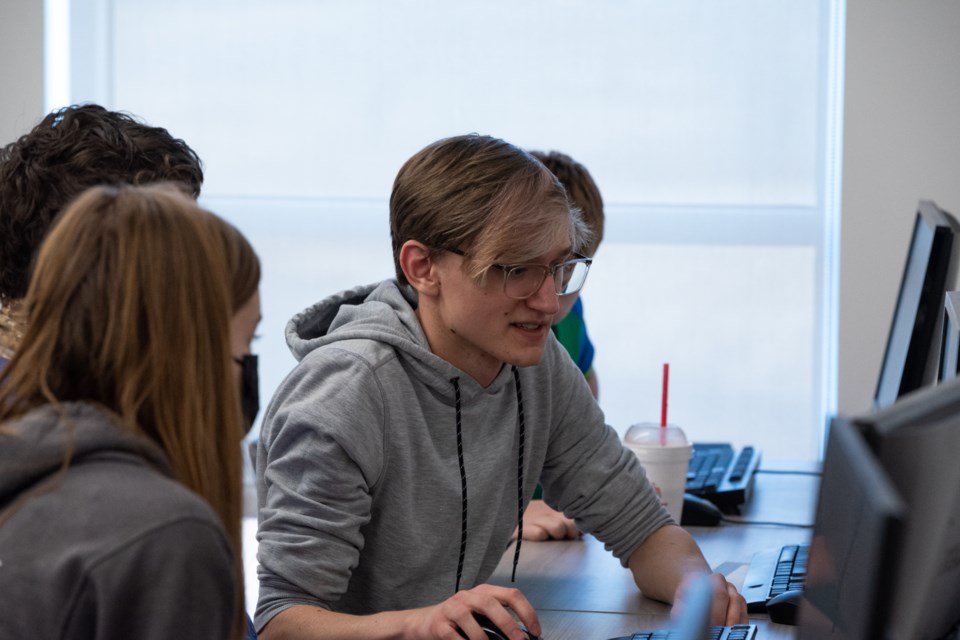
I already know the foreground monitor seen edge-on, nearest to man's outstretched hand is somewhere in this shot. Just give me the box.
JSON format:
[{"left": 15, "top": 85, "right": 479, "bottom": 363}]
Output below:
[{"left": 798, "top": 418, "right": 906, "bottom": 640}]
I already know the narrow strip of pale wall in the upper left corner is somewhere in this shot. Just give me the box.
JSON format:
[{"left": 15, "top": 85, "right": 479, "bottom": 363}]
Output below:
[{"left": 0, "top": 0, "right": 43, "bottom": 145}]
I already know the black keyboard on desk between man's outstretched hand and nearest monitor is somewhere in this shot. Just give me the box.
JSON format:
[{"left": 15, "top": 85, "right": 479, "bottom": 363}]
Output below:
[{"left": 741, "top": 544, "right": 810, "bottom": 613}]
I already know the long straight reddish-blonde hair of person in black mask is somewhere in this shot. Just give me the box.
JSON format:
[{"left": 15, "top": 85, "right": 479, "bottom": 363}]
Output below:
[{"left": 0, "top": 185, "right": 245, "bottom": 638}]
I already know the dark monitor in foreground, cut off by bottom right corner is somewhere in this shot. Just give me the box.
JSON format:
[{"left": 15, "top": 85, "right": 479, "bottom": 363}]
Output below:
[{"left": 854, "top": 378, "right": 960, "bottom": 640}]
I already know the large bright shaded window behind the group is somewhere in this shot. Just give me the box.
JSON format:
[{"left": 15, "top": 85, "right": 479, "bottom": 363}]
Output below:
[{"left": 60, "top": 0, "right": 843, "bottom": 458}]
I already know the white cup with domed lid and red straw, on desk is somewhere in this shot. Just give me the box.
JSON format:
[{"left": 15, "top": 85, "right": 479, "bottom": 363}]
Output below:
[{"left": 623, "top": 422, "right": 693, "bottom": 524}]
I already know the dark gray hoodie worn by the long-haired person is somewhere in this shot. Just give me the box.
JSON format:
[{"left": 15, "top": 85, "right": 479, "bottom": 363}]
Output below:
[{"left": 0, "top": 403, "right": 239, "bottom": 640}]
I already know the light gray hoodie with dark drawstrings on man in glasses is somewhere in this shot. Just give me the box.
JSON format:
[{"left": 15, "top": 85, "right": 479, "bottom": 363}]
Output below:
[{"left": 256, "top": 280, "right": 671, "bottom": 629}]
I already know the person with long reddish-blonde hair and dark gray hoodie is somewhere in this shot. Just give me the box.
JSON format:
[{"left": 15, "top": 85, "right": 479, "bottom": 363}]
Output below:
[{"left": 0, "top": 185, "right": 251, "bottom": 639}]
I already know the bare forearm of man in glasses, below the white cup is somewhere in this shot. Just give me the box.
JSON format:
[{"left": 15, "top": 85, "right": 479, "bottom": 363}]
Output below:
[{"left": 627, "top": 525, "right": 710, "bottom": 604}]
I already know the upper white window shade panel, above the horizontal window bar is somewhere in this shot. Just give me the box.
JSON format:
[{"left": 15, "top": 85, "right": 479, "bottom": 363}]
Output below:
[{"left": 110, "top": 0, "right": 822, "bottom": 206}]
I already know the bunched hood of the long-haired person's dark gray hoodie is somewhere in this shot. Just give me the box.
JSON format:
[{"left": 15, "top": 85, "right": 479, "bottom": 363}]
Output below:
[{"left": 0, "top": 402, "right": 172, "bottom": 510}]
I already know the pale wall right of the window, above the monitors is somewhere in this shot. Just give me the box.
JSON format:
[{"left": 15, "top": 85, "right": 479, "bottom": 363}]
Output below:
[{"left": 838, "top": 0, "right": 960, "bottom": 413}]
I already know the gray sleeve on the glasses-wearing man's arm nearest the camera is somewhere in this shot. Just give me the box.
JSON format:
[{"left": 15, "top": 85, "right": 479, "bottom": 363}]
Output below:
[{"left": 256, "top": 347, "right": 385, "bottom": 629}]
